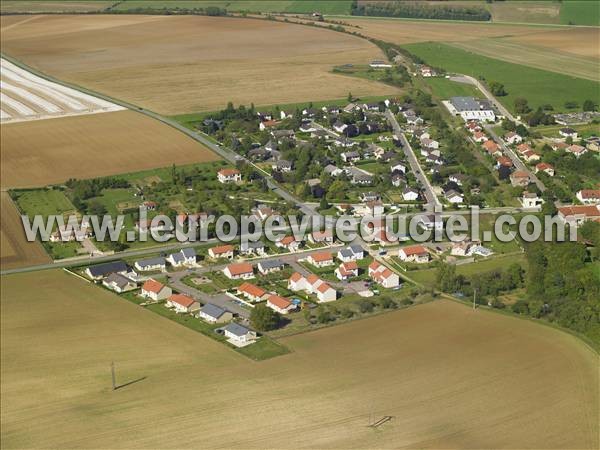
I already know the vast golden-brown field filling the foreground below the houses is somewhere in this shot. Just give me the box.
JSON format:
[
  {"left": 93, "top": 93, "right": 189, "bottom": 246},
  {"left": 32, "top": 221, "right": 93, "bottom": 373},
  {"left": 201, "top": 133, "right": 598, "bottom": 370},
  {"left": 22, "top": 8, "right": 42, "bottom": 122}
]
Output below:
[{"left": 1, "top": 271, "right": 598, "bottom": 448}]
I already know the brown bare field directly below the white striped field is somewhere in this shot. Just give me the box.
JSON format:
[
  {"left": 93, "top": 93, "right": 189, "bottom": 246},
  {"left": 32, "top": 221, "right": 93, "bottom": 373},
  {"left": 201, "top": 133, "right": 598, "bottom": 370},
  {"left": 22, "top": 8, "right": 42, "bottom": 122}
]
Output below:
[{"left": 1, "top": 111, "right": 219, "bottom": 188}]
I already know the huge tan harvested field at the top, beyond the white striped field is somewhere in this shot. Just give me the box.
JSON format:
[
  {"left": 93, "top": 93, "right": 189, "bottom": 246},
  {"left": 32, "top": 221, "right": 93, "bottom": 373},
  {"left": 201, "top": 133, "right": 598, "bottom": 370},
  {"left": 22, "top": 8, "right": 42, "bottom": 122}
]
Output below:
[{"left": 2, "top": 15, "right": 398, "bottom": 114}]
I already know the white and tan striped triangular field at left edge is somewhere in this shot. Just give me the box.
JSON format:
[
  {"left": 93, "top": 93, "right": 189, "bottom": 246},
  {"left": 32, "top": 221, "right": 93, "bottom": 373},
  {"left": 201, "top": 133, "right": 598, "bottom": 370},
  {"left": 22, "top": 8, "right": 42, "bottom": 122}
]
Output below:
[{"left": 0, "top": 58, "right": 124, "bottom": 123}]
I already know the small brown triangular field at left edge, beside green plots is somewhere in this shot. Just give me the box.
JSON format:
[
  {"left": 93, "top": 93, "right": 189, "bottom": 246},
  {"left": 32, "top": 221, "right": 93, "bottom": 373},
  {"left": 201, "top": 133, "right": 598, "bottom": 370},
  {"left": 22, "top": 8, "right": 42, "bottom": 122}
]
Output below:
[{"left": 0, "top": 191, "right": 50, "bottom": 270}]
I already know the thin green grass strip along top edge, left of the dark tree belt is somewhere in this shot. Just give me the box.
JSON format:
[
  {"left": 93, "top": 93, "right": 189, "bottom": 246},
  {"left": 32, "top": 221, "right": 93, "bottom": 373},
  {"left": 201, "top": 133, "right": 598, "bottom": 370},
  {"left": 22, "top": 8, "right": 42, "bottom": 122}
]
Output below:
[{"left": 114, "top": 0, "right": 352, "bottom": 14}]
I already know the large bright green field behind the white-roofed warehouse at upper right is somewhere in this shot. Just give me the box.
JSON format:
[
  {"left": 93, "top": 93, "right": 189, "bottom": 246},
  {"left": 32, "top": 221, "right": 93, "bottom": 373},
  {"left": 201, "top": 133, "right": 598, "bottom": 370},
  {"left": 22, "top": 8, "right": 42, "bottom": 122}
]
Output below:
[{"left": 403, "top": 42, "right": 600, "bottom": 112}]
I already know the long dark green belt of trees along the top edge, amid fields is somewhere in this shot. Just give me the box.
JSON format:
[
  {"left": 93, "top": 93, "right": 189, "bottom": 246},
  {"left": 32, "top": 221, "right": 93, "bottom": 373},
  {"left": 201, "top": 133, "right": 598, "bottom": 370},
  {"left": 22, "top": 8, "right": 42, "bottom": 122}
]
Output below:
[{"left": 352, "top": 1, "right": 492, "bottom": 21}]
